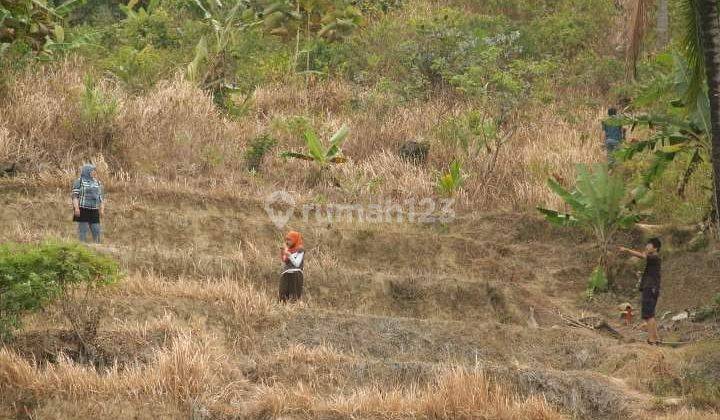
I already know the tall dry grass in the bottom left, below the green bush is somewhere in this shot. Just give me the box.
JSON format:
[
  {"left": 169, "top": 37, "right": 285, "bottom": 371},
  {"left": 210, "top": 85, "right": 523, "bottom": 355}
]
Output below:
[{"left": 0, "top": 332, "right": 245, "bottom": 414}]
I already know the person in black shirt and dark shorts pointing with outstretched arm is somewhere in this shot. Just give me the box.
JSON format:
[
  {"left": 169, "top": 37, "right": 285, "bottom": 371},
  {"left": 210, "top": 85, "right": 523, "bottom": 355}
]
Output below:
[{"left": 620, "top": 238, "right": 662, "bottom": 344}]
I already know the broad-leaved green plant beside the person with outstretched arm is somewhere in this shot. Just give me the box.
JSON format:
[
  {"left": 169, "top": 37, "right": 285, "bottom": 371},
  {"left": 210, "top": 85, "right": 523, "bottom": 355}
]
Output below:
[{"left": 538, "top": 165, "right": 642, "bottom": 278}]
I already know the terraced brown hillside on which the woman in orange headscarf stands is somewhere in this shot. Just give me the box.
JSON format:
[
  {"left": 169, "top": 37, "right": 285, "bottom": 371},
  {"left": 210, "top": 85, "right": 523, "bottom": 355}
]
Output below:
[{"left": 0, "top": 179, "right": 712, "bottom": 418}]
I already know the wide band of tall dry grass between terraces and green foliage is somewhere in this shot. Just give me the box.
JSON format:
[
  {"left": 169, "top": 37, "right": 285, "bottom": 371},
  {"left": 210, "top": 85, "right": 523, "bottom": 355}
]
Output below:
[{"left": 0, "top": 54, "right": 603, "bottom": 210}]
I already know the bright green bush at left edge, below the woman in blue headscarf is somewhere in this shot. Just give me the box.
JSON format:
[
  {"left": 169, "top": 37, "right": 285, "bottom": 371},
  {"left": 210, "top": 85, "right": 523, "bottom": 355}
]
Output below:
[{"left": 0, "top": 242, "right": 120, "bottom": 339}]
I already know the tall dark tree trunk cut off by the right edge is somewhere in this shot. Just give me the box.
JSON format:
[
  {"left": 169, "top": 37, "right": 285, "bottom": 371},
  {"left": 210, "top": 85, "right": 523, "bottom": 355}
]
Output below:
[{"left": 697, "top": 0, "right": 720, "bottom": 234}]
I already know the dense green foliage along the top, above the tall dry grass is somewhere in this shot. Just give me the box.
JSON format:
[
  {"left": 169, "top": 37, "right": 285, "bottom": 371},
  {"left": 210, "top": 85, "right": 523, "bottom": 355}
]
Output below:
[{"left": 0, "top": 0, "right": 618, "bottom": 100}]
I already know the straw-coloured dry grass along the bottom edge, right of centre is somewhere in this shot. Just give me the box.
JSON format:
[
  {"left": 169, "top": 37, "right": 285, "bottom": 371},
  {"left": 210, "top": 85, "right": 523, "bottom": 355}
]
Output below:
[{"left": 251, "top": 368, "right": 562, "bottom": 419}]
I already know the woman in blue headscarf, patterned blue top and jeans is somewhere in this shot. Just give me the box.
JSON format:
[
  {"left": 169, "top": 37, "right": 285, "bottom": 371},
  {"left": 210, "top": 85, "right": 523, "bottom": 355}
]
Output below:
[{"left": 72, "top": 164, "right": 105, "bottom": 244}]
